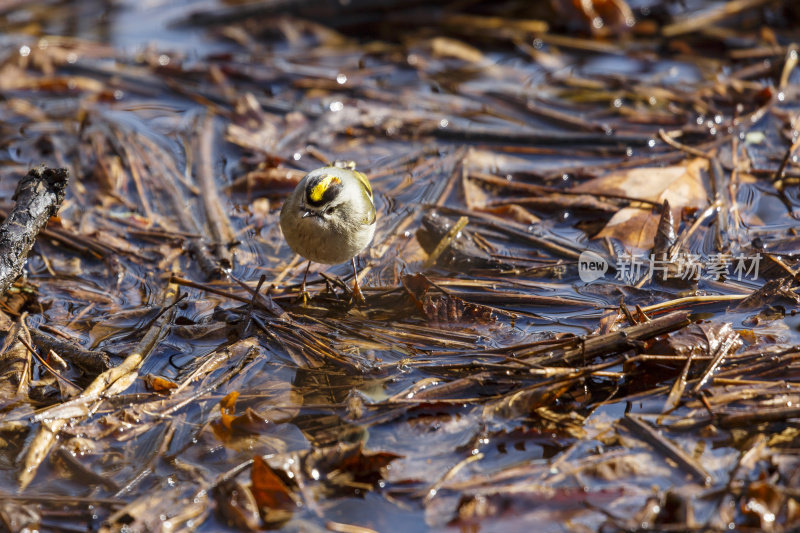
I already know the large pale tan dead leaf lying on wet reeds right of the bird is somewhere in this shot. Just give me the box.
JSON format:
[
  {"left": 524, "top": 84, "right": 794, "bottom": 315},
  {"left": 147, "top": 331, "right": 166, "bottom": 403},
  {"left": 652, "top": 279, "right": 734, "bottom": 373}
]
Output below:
[{"left": 572, "top": 157, "right": 708, "bottom": 250}]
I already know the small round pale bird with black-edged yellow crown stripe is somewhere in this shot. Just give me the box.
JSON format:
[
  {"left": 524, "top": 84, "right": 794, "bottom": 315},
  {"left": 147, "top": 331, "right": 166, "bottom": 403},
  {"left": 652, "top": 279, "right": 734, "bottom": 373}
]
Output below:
[{"left": 281, "top": 163, "right": 376, "bottom": 302}]
